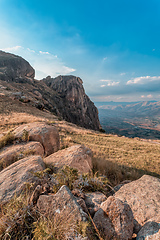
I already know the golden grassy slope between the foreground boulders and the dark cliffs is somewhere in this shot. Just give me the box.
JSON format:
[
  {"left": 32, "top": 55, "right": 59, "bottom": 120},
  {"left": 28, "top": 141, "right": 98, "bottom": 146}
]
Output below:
[{"left": 0, "top": 97, "right": 160, "bottom": 185}]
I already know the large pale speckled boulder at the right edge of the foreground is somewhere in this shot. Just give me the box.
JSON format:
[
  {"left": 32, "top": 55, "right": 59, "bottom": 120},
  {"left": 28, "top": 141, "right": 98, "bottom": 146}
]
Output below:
[{"left": 114, "top": 175, "right": 160, "bottom": 233}]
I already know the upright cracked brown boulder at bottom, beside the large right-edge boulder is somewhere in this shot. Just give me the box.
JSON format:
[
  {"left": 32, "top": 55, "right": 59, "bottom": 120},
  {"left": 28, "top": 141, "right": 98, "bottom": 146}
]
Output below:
[{"left": 93, "top": 197, "right": 133, "bottom": 240}]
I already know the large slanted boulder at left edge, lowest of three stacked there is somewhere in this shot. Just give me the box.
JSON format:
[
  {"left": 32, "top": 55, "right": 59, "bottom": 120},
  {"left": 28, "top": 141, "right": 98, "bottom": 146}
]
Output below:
[{"left": 0, "top": 155, "right": 45, "bottom": 203}]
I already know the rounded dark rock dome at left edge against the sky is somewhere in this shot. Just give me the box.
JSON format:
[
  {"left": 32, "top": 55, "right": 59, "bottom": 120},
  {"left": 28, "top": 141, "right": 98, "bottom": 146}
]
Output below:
[{"left": 0, "top": 51, "right": 35, "bottom": 81}]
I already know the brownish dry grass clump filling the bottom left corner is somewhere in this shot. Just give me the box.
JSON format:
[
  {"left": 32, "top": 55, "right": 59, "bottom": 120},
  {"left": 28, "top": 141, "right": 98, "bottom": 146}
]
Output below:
[{"left": 0, "top": 190, "right": 38, "bottom": 240}]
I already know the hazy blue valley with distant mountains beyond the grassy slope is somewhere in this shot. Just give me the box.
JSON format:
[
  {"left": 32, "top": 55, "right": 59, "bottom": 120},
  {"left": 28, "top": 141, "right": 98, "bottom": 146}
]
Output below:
[{"left": 95, "top": 102, "right": 160, "bottom": 140}]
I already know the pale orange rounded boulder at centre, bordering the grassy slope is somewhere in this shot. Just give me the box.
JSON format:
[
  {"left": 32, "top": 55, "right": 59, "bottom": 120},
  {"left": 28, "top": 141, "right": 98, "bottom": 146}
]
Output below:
[{"left": 44, "top": 145, "right": 92, "bottom": 173}]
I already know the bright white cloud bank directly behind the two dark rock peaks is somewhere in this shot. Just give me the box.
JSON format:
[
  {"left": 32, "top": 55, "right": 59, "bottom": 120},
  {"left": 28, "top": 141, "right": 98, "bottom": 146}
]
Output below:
[{"left": 2, "top": 46, "right": 76, "bottom": 79}]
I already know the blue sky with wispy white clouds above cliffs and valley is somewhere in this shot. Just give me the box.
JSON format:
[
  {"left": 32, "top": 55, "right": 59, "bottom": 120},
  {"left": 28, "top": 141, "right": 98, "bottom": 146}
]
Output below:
[{"left": 0, "top": 0, "right": 160, "bottom": 102}]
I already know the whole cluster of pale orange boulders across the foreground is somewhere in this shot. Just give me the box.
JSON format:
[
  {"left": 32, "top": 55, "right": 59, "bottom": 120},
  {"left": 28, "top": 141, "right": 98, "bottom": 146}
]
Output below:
[{"left": 0, "top": 122, "right": 160, "bottom": 240}]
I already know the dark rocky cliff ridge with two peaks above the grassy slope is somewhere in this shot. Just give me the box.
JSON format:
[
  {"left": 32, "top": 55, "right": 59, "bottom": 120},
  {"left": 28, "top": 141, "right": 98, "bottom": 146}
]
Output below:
[{"left": 0, "top": 51, "right": 101, "bottom": 130}]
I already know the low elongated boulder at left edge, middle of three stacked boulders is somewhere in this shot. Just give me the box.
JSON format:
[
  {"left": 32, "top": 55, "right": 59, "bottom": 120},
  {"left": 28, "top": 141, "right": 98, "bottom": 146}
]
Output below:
[{"left": 0, "top": 142, "right": 44, "bottom": 168}]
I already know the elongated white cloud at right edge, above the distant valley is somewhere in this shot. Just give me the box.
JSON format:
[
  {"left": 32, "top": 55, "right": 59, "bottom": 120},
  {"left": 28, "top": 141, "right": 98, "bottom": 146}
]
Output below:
[{"left": 126, "top": 76, "right": 160, "bottom": 85}]
